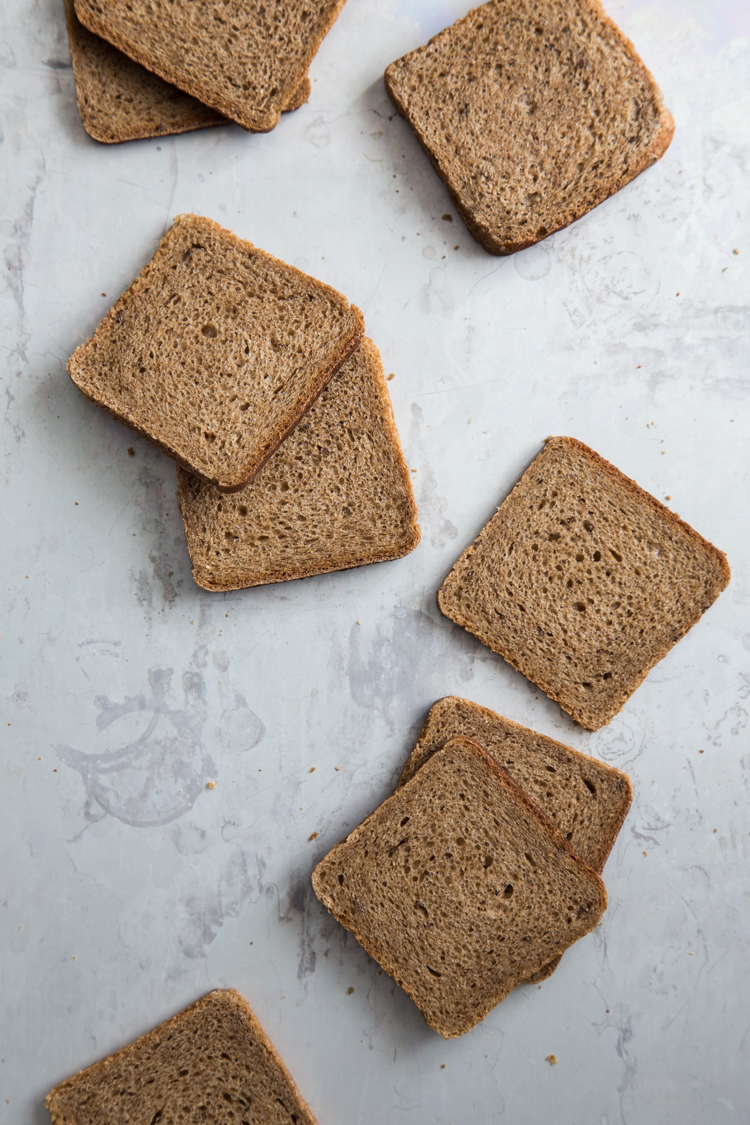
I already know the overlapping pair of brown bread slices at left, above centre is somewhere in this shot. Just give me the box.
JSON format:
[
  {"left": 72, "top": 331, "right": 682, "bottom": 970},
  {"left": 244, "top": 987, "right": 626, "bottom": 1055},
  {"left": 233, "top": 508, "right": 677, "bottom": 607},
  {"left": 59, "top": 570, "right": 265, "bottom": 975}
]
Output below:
[{"left": 67, "top": 215, "right": 419, "bottom": 591}]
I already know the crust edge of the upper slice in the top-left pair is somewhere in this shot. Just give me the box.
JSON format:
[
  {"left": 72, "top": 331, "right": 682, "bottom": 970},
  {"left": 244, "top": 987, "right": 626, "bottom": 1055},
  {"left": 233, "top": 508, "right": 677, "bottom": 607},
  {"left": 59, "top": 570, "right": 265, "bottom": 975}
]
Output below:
[{"left": 75, "top": 0, "right": 346, "bottom": 133}]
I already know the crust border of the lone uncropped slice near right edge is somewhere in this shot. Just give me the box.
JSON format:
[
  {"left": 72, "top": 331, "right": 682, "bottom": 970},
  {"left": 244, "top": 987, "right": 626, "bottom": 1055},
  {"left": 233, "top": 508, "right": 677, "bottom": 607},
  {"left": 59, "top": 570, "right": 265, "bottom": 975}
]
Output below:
[{"left": 437, "top": 438, "right": 731, "bottom": 730}]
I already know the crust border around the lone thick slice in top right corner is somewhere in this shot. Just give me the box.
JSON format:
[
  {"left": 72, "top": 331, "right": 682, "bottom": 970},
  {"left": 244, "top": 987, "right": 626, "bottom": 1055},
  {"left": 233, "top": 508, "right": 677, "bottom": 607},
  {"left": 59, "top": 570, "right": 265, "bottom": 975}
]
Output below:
[{"left": 385, "top": 0, "right": 675, "bottom": 255}]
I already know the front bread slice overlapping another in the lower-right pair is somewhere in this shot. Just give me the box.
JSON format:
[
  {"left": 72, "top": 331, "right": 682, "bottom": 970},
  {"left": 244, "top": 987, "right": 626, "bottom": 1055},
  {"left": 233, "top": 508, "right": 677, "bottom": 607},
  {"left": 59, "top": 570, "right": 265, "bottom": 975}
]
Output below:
[{"left": 313, "top": 738, "right": 607, "bottom": 1038}]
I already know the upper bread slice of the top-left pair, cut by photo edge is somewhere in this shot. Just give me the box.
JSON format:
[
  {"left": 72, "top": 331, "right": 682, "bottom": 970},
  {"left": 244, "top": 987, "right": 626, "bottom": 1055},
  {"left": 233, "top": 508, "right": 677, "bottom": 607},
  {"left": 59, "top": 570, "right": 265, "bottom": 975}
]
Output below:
[{"left": 75, "top": 0, "right": 344, "bottom": 133}]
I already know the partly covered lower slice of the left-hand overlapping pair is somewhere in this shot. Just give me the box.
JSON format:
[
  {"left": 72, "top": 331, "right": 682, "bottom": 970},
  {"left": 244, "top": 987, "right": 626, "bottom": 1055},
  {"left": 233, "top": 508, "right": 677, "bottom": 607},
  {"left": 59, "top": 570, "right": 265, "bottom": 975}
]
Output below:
[{"left": 178, "top": 339, "right": 419, "bottom": 590}]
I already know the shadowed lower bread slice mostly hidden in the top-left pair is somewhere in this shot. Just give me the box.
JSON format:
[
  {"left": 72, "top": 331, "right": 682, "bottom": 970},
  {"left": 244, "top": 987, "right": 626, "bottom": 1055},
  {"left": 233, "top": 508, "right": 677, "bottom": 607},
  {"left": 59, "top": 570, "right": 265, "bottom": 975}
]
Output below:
[{"left": 64, "top": 0, "right": 227, "bottom": 144}]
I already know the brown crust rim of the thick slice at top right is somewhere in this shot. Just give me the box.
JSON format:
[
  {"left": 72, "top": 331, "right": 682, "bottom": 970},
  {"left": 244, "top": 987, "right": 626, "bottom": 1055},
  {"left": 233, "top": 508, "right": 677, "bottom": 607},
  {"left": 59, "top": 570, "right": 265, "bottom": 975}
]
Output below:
[{"left": 383, "top": 0, "right": 675, "bottom": 257}]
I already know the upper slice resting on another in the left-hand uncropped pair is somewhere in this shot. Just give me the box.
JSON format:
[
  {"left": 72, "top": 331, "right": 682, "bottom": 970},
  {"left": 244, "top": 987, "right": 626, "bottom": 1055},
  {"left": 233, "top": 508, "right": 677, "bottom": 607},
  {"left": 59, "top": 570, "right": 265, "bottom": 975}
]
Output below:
[{"left": 67, "top": 215, "right": 364, "bottom": 492}]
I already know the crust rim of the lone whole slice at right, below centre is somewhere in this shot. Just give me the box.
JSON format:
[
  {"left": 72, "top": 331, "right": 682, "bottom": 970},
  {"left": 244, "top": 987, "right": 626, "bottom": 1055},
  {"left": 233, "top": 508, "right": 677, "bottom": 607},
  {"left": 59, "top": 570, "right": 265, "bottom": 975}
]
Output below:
[{"left": 437, "top": 438, "right": 731, "bottom": 730}]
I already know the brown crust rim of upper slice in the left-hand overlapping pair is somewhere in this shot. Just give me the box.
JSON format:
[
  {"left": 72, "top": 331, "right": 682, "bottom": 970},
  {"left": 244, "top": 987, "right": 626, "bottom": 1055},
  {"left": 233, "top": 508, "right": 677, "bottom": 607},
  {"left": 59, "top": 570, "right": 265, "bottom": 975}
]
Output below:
[{"left": 67, "top": 214, "right": 364, "bottom": 493}]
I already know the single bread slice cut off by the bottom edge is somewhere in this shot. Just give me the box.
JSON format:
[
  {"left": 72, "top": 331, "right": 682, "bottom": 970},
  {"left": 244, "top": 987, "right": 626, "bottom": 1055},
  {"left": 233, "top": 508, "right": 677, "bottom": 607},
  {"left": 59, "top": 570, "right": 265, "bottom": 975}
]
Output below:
[{"left": 45, "top": 989, "right": 316, "bottom": 1125}]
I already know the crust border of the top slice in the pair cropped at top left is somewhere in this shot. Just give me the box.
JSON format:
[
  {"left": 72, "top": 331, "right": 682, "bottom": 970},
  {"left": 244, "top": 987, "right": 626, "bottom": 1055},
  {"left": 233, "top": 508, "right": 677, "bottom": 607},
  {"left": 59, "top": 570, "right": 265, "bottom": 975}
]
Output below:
[{"left": 75, "top": 0, "right": 345, "bottom": 133}]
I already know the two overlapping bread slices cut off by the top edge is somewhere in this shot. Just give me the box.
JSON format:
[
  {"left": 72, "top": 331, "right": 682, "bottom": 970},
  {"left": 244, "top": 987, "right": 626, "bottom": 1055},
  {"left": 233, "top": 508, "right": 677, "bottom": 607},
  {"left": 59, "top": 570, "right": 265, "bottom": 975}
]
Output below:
[{"left": 64, "top": 0, "right": 344, "bottom": 144}]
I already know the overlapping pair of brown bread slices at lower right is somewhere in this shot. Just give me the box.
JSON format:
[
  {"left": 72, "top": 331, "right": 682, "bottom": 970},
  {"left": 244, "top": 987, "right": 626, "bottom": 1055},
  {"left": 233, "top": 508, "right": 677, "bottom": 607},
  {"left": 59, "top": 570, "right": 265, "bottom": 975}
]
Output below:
[{"left": 313, "top": 696, "right": 632, "bottom": 1038}]
